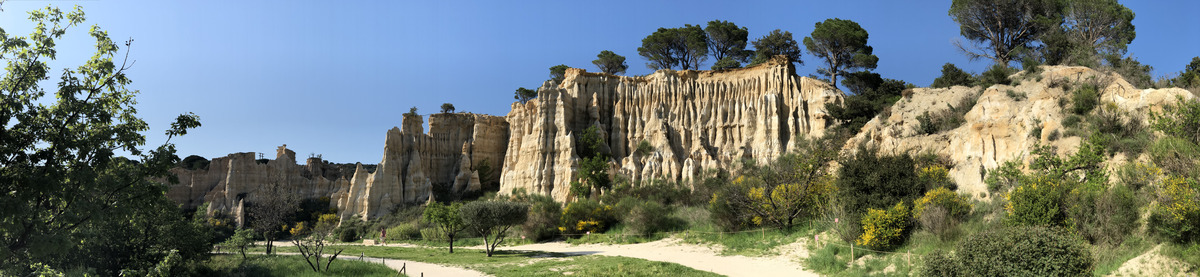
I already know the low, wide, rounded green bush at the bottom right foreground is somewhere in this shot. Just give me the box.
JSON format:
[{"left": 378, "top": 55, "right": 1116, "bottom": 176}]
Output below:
[{"left": 925, "top": 227, "right": 1096, "bottom": 276}]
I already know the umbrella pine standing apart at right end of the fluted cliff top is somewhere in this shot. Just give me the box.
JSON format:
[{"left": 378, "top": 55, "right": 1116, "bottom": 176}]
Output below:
[{"left": 804, "top": 18, "right": 880, "bottom": 85}]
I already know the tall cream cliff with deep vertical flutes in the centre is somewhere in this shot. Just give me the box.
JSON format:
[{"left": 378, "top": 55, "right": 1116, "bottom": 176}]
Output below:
[{"left": 500, "top": 59, "right": 844, "bottom": 200}]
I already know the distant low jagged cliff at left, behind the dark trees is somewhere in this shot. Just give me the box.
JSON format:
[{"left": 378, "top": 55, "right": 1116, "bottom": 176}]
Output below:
[{"left": 167, "top": 145, "right": 348, "bottom": 219}]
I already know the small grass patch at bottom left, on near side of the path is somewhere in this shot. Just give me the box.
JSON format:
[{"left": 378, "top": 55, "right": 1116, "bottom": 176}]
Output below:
[{"left": 204, "top": 254, "right": 397, "bottom": 277}]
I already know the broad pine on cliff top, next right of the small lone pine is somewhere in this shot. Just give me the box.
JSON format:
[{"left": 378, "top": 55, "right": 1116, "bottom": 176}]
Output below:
[{"left": 637, "top": 24, "right": 708, "bottom": 70}]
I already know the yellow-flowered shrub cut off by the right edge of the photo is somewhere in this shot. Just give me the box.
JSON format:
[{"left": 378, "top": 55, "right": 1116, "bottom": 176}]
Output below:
[{"left": 1150, "top": 176, "right": 1200, "bottom": 242}]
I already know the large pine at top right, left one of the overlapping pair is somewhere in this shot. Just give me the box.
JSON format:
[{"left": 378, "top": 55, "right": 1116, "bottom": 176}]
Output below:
[{"left": 949, "top": 0, "right": 1063, "bottom": 66}]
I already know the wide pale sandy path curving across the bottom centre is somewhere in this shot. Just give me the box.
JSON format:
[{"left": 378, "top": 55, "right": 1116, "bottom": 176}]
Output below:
[{"left": 484, "top": 239, "right": 818, "bottom": 276}]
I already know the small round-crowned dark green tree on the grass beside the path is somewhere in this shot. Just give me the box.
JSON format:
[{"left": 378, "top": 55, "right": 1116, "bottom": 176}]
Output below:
[{"left": 460, "top": 201, "right": 529, "bottom": 257}]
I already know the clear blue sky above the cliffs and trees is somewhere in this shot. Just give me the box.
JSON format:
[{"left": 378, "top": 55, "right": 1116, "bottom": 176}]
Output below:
[{"left": 0, "top": 0, "right": 1200, "bottom": 163}]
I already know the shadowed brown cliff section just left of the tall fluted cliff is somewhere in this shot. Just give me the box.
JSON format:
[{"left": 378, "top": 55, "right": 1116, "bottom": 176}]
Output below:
[{"left": 331, "top": 114, "right": 509, "bottom": 221}]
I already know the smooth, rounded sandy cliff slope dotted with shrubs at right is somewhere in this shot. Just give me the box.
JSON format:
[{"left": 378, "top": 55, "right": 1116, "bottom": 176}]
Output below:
[{"left": 844, "top": 66, "right": 1193, "bottom": 197}]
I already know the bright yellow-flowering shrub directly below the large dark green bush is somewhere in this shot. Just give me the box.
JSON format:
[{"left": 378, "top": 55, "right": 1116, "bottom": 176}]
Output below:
[{"left": 856, "top": 203, "right": 912, "bottom": 249}]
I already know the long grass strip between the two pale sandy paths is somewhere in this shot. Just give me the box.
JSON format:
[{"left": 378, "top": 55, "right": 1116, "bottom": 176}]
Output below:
[{"left": 248, "top": 246, "right": 718, "bottom": 276}]
